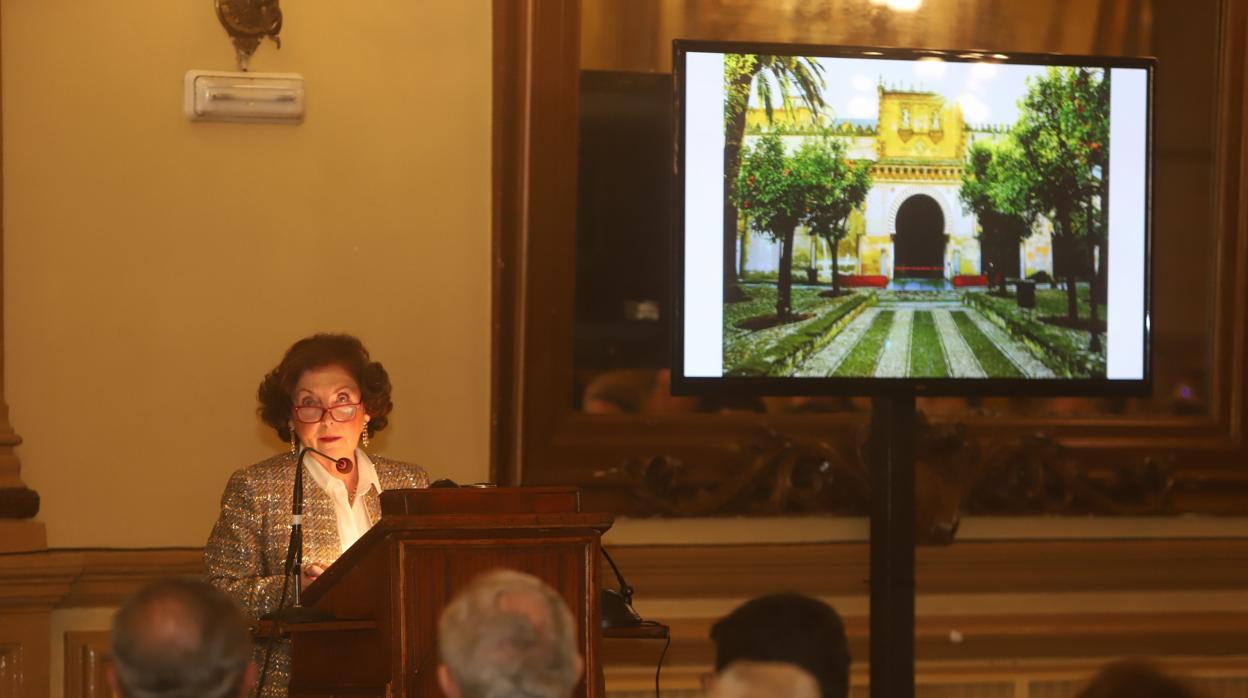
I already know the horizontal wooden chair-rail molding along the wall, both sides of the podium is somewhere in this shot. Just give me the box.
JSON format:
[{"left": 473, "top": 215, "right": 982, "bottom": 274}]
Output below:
[{"left": 0, "top": 538, "right": 1248, "bottom": 609}]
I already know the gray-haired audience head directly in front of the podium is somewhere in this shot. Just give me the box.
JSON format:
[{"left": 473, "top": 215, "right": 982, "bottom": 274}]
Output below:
[{"left": 438, "top": 569, "right": 582, "bottom": 698}]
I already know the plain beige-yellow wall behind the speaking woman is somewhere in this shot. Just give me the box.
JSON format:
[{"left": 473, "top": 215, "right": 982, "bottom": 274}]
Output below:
[{"left": 0, "top": 0, "right": 490, "bottom": 547}]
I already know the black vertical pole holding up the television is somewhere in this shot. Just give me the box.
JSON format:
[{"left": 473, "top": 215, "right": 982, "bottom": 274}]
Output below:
[{"left": 867, "top": 392, "right": 916, "bottom": 698}]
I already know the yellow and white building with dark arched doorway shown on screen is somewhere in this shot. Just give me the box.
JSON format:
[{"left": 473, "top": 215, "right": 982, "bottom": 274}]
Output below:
[{"left": 739, "top": 85, "right": 1052, "bottom": 281}]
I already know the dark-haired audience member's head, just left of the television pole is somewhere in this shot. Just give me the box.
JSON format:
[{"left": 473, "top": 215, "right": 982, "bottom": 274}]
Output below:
[{"left": 710, "top": 593, "right": 850, "bottom": 698}]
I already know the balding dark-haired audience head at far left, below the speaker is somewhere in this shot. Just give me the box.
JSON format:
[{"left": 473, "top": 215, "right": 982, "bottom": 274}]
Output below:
[{"left": 112, "top": 579, "right": 251, "bottom": 698}]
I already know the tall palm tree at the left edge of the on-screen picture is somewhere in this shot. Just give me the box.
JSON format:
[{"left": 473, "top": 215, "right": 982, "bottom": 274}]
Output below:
[{"left": 724, "top": 54, "right": 824, "bottom": 302}]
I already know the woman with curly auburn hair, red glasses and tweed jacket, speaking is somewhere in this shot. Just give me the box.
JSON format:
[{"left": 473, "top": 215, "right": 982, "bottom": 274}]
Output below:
[{"left": 203, "top": 335, "right": 429, "bottom": 697}]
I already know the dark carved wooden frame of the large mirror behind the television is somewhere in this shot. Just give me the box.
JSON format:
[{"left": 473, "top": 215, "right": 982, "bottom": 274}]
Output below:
[{"left": 492, "top": 0, "right": 1248, "bottom": 523}]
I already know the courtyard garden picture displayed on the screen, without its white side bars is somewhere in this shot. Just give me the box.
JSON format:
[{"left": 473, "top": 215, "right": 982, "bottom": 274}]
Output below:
[{"left": 724, "top": 54, "right": 1109, "bottom": 378}]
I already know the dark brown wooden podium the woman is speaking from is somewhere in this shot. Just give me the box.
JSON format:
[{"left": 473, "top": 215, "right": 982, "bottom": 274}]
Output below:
[{"left": 282, "top": 487, "right": 613, "bottom": 698}]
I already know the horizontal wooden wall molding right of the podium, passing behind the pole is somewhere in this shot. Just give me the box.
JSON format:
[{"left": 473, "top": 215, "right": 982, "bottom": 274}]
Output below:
[{"left": 609, "top": 538, "right": 1248, "bottom": 602}]
